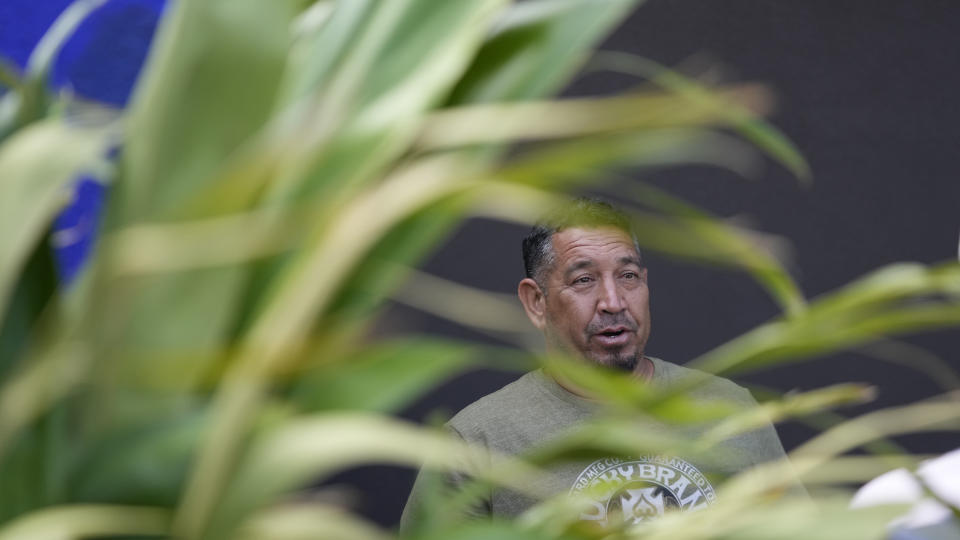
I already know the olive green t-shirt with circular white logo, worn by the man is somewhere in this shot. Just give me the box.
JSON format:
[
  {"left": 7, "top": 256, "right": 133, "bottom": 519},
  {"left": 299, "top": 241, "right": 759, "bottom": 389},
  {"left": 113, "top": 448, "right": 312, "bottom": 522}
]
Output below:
[{"left": 401, "top": 358, "right": 785, "bottom": 530}]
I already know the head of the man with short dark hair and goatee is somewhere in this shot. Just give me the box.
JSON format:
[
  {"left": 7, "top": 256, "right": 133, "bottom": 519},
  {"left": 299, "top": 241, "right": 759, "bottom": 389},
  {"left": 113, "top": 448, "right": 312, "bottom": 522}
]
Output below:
[{"left": 517, "top": 199, "right": 650, "bottom": 371}]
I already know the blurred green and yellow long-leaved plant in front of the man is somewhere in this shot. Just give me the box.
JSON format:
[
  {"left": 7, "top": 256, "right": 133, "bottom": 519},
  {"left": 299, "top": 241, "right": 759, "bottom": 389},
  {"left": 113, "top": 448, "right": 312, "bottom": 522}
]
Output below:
[{"left": 0, "top": 0, "right": 960, "bottom": 538}]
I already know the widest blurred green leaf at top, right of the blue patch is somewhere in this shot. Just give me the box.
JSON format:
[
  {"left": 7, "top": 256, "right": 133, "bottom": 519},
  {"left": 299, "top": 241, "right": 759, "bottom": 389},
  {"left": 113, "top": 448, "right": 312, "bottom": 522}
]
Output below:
[{"left": 121, "top": 0, "right": 295, "bottom": 221}]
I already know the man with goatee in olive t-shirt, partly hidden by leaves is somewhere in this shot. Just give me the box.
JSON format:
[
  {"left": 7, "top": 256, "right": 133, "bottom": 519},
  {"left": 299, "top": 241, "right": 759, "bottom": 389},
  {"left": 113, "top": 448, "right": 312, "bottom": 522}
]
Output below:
[{"left": 401, "top": 199, "right": 784, "bottom": 527}]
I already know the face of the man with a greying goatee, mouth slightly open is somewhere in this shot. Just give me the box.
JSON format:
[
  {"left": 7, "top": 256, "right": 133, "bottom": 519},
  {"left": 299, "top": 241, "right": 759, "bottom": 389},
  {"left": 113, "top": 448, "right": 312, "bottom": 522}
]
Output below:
[{"left": 542, "top": 228, "right": 650, "bottom": 371}]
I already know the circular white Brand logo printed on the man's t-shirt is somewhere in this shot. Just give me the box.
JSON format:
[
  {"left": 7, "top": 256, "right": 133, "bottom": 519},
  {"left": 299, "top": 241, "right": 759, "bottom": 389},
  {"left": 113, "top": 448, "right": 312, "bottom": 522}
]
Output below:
[{"left": 570, "top": 456, "right": 716, "bottom": 525}]
